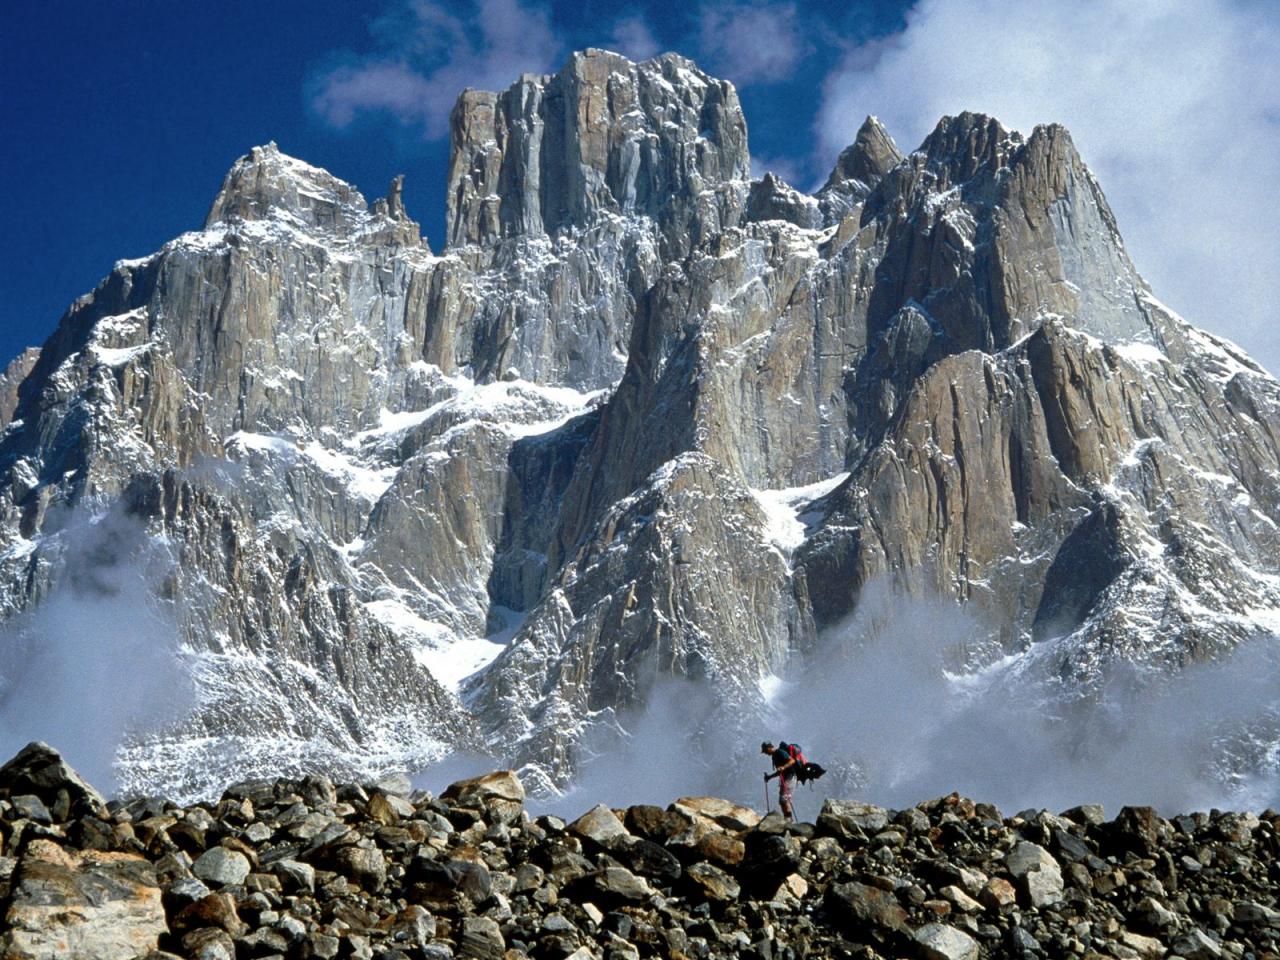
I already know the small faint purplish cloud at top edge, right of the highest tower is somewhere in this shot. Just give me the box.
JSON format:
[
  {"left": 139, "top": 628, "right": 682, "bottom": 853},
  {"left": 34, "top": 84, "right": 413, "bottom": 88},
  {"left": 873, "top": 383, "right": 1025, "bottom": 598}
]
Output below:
[{"left": 699, "top": 4, "right": 809, "bottom": 86}]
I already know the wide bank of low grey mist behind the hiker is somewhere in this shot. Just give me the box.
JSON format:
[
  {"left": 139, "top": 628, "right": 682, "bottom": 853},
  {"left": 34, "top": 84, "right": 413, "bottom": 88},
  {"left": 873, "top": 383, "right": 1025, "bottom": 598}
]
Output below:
[{"left": 542, "top": 586, "right": 1280, "bottom": 819}]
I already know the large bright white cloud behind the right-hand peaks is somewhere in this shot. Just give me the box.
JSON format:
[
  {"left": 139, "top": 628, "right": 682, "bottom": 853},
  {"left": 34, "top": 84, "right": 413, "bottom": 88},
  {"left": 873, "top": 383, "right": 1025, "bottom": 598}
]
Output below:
[{"left": 818, "top": 0, "right": 1280, "bottom": 372}]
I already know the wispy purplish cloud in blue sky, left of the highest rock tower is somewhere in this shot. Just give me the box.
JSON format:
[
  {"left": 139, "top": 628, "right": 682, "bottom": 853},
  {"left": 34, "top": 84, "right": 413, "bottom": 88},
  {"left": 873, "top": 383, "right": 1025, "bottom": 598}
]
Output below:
[{"left": 311, "top": 0, "right": 562, "bottom": 137}]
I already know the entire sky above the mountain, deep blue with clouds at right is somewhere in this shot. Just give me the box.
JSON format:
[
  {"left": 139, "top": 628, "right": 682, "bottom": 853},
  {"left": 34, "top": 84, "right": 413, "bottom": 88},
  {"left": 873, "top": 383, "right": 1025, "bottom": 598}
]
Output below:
[{"left": 0, "top": 0, "right": 1280, "bottom": 370}]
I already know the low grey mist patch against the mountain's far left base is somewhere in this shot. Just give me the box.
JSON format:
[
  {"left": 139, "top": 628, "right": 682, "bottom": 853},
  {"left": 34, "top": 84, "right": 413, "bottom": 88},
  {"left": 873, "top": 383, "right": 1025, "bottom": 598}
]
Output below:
[{"left": 0, "top": 508, "right": 193, "bottom": 795}]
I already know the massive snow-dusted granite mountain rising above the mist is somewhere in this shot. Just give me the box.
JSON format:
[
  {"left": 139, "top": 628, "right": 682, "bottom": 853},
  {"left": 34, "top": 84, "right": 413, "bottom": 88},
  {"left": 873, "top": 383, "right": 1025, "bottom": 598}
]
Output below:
[{"left": 0, "top": 51, "right": 1280, "bottom": 794}]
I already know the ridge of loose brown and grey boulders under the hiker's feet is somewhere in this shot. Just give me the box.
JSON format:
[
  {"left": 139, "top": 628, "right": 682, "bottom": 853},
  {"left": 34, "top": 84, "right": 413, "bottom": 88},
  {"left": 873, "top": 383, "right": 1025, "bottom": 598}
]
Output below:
[{"left": 0, "top": 744, "right": 1280, "bottom": 960}]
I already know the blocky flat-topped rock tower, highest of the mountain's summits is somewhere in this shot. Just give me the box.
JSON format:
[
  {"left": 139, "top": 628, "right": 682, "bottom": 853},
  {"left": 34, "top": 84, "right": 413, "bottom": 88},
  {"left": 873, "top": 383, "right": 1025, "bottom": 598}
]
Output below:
[{"left": 447, "top": 50, "right": 750, "bottom": 246}]
